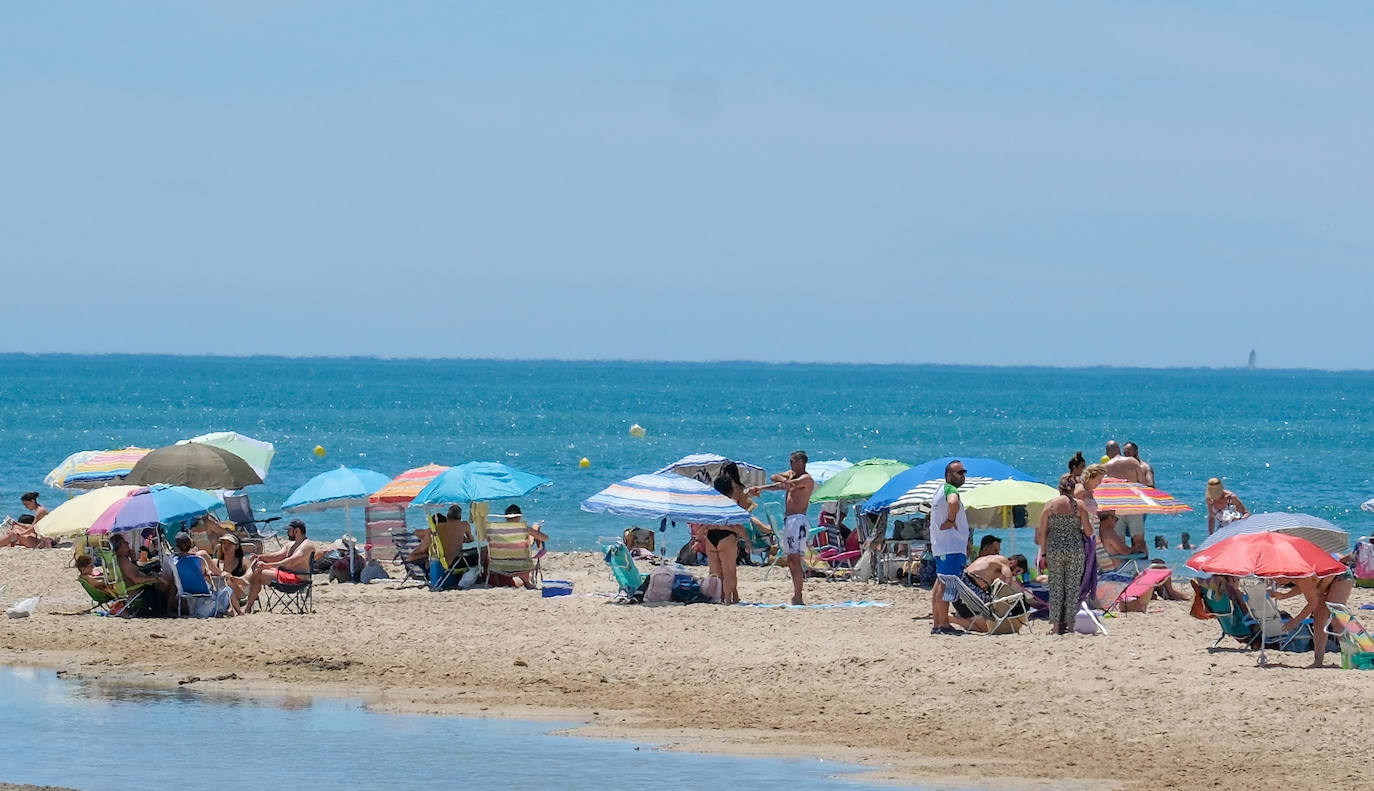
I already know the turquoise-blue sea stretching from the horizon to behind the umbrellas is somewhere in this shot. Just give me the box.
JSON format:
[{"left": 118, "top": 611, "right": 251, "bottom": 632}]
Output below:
[{"left": 0, "top": 354, "right": 1374, "bottom": 559}]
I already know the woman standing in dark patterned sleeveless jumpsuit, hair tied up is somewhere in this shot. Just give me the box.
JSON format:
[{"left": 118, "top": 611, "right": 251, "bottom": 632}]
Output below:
[{"left": 1035, "top": 464, "right": 1096, "bottom": 634}]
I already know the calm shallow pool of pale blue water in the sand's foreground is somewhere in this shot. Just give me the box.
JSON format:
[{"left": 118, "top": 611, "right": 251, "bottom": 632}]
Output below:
[{"left": 0, "top": 667, "right": 912, "bottom": 791}]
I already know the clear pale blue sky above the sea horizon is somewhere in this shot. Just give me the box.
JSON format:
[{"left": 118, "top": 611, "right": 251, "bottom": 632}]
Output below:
[{"left": 0, "top": 0, "right": 1374, "bottom": 368}]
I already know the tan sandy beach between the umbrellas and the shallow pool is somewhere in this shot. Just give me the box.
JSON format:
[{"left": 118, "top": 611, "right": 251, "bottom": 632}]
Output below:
[{"left": 0, "top": 549, "right": 1374, "bottom": 791}]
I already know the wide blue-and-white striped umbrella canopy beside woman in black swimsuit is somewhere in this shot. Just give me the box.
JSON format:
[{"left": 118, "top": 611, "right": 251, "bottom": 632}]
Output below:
[{"left": 583, "top": 472, "right": 749, "bottom": 525}]
